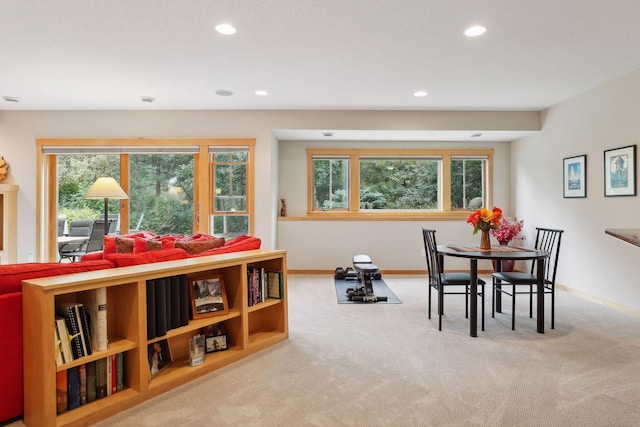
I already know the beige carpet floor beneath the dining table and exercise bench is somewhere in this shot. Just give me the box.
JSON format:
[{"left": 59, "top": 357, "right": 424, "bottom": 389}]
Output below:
[{"left": 8, "top": 274, "right": 640, "bottom": 427}]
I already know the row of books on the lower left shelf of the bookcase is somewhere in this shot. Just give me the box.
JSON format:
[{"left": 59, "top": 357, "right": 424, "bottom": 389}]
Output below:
[{"left": 56, "top": 353, "right": 124, "bottom": 414}]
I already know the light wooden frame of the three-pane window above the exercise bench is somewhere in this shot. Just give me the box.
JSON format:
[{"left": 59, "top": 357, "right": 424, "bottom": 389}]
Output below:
[{"left": 307, "top": 148, "right": 494, "bottom": 220}]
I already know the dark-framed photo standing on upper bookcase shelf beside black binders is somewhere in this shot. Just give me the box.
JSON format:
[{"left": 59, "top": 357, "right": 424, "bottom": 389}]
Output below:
[{"left": 189, "top": 276, "right": 229, "bottom": 319}]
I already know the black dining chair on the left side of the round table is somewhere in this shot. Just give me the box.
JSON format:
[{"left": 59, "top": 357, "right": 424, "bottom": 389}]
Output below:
[{"left": 422, "top": 228, "right": 485, "bottom": 331}]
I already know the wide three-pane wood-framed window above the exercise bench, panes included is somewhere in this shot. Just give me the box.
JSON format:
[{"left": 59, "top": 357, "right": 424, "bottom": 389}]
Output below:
[{"left": 307, "top": 149, "right": 493, "bottom": 216}]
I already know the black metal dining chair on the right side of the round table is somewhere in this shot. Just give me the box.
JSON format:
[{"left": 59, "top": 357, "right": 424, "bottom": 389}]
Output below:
[{"left": 491, "top": 227, "right": 564, "bottom": 330}]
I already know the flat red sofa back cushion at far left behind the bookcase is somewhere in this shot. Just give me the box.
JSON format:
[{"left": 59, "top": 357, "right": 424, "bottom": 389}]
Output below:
[{"left": 0, "top": 259, "right": 114, "bottom": 294}]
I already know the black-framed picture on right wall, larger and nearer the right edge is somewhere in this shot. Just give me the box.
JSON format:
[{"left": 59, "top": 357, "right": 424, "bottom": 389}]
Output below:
[{"left": 604, "top": 145, "right": 636, "bottom": 197}]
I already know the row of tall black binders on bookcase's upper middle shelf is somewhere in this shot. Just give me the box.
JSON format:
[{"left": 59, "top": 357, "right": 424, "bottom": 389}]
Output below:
[{"left": 146, "top": 274, "right": 190, "bottom": 339}]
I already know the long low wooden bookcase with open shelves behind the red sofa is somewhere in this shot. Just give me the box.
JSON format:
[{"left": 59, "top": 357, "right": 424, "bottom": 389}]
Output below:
[{"left": 23, "top": 250, "right": 289, "bottom": 427}]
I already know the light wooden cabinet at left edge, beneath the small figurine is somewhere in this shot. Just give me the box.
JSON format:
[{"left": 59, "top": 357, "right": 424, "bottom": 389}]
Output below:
[{"left": 0, "top": 184, "right": 18, "bottom": 264}]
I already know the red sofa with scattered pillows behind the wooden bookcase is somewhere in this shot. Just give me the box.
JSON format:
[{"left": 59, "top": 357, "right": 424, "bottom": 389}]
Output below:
[{"left": 0, "top": 235, "right": 261, "bottom": 424}]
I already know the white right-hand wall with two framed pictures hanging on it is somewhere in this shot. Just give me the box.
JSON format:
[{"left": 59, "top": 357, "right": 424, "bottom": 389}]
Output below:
[{"left": 511, "top": 70, "right": 640, "bottom": 310}]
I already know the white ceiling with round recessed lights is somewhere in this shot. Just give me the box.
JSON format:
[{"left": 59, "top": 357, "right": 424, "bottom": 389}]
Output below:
[{"left": 0, "top": 0, "right": 640, "bottom": 140}]
